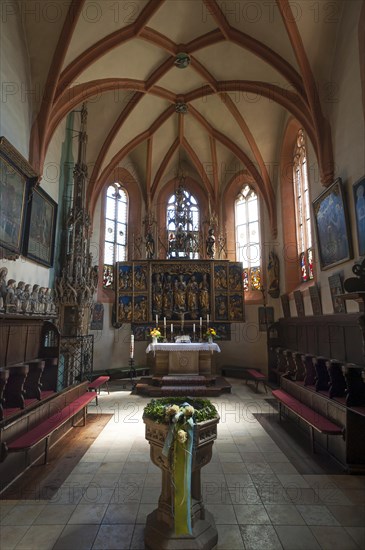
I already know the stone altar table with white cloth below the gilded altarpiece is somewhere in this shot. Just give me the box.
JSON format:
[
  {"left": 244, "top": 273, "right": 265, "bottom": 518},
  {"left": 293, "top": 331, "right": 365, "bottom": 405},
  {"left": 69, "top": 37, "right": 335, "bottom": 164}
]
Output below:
[{"left": 146, "top": 342, "right": 221, "bottom": 376}]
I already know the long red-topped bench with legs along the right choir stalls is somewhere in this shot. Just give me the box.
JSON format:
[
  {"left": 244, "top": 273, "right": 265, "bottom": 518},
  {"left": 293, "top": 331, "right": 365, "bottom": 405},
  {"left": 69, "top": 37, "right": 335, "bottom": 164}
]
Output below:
[{"left": 272, "top": 390, "right": 344, "bottom": 452}]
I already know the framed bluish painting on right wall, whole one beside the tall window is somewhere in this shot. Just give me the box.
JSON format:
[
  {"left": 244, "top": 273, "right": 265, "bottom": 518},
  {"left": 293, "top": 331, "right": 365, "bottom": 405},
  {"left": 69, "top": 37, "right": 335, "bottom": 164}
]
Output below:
[{"left": 313, "top": 178, "right": 352, "bottom": 270}]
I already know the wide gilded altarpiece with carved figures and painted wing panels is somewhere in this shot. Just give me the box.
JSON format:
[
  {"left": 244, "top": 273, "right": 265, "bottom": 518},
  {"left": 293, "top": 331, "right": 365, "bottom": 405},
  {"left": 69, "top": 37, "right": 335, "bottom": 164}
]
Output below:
[{"left": 115, "top": 260, "right": 244, "bottom": 324}]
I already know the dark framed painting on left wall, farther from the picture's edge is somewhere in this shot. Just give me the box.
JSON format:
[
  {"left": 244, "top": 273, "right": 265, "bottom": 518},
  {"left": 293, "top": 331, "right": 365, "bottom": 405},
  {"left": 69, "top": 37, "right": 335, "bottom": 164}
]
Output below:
[{"left": 24, "top": 187, "right": 57, "bottom": 267}]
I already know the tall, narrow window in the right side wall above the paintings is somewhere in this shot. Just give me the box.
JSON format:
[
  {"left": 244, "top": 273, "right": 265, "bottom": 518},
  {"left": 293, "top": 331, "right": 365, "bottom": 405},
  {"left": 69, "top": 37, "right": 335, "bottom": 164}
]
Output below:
[{"left": 293, "top": 129, "right": 314, "bottom": 283}]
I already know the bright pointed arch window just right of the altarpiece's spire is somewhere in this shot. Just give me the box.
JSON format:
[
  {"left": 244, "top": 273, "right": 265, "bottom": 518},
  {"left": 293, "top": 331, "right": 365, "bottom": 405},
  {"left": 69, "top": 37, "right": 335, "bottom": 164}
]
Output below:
[{"left": 235, "top": 185, "right": 261, "bottom": 292}]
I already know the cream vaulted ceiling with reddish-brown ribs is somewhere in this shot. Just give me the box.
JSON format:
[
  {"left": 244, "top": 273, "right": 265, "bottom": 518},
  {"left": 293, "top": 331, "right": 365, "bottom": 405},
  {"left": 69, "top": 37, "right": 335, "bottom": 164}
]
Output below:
[{"left": 26, "top": 0, "right": 346, "bottom": 232}]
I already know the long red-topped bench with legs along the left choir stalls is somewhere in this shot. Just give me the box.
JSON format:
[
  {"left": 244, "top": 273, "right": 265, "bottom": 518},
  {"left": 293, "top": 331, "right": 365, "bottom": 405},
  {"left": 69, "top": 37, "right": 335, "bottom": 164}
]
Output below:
[{"left": 4, "top": 392, "right": 96, "bottom": 464}]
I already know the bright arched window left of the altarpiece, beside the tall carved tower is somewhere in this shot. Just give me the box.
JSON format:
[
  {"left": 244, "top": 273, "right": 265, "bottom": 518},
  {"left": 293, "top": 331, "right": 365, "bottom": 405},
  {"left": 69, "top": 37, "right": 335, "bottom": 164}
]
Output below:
[{"left": 103, "top": 183, "right": 128, "bottom": 288}]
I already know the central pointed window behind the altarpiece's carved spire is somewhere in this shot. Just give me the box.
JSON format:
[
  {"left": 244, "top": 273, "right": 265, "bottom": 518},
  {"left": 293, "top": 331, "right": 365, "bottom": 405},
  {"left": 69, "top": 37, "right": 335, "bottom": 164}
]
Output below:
[{"left": 166, "top": 185, "right": 200, "bottom": 260}]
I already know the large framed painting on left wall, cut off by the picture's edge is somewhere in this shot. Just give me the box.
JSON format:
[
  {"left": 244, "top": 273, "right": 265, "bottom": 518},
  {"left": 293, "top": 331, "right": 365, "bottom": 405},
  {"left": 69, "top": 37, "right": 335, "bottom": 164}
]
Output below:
[{"left": 0, "top": 137, "right": 37, "bottom": 259}]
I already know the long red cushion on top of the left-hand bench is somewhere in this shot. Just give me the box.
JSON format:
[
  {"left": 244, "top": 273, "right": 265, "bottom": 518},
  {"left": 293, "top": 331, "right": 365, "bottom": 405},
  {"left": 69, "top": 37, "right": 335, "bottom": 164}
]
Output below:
[{"left": 7, "top": 393, "right": 95, "bottom": 451}]
